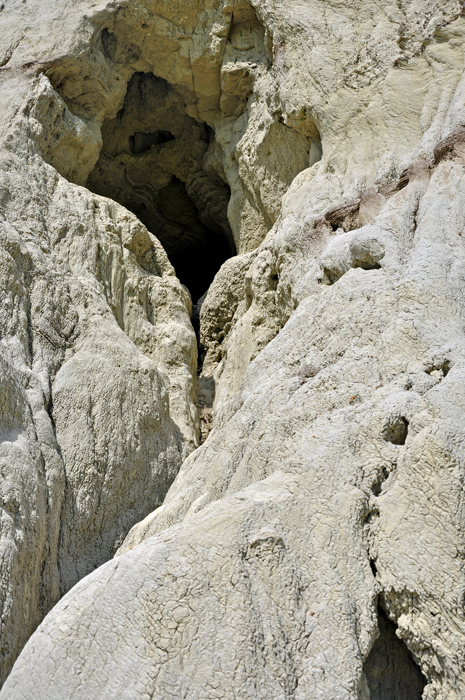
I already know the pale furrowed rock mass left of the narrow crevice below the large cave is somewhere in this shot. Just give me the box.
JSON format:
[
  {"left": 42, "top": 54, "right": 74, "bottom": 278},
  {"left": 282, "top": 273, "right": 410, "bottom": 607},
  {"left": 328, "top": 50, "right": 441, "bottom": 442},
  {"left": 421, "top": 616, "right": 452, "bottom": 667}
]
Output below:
[{"left": 0, "top": 65, "right": 198, "bottom": 674}]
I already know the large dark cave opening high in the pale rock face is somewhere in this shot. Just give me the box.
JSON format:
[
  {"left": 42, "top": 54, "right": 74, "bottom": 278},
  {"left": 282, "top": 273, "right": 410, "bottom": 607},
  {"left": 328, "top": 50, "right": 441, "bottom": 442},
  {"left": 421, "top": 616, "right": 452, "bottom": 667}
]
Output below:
[{"left": 87, "top": 72, "right": 236, "bottom": 303}]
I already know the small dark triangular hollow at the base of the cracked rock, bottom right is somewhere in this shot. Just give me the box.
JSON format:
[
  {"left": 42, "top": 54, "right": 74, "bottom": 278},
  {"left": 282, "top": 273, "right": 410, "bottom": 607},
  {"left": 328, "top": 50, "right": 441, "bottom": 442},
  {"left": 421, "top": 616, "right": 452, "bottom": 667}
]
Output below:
[{"left": 360, "top": 605, "right": 426, "bottom": 700}]
